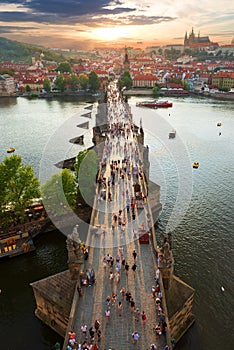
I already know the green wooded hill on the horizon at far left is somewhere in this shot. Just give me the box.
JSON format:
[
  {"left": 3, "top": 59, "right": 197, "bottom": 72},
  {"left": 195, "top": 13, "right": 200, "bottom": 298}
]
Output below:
[{"left": 0, "top": 37, "right": 64, "bottom": 63}]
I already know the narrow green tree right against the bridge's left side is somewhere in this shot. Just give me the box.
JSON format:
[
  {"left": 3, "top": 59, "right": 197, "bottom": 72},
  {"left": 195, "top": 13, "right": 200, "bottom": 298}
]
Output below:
[{"left": 74, "top": 150, "right": 98, "bottom": 206}]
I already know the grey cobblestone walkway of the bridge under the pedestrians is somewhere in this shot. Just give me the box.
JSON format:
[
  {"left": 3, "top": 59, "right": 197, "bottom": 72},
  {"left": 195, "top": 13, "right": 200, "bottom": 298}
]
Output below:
[{"left": 74, "top": 82, "right": 166, "bottom": 350}]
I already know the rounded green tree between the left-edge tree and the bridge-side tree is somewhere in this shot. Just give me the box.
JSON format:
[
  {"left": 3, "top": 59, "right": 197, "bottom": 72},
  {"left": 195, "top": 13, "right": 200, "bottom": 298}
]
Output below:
[{"left": 41, "top": 169, "right": 76, "bottom": 215}]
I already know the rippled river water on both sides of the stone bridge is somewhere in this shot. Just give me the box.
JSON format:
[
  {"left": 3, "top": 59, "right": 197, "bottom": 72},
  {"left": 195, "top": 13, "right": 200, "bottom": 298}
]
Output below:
[{"left": 0, "top": 97, "right": 234, "bottom": 350}]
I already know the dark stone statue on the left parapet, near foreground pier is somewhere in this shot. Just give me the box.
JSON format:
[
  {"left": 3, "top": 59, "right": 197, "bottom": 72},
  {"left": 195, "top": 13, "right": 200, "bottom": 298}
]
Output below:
[{"left": 66, "top": 225, "right": 84, "bottom": 280}]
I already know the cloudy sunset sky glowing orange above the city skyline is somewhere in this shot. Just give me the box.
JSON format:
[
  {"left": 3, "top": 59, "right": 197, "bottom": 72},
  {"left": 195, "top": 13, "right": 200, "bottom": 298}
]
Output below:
[{"left": 0, "top": 0, "right": 234, "bottom": 50}]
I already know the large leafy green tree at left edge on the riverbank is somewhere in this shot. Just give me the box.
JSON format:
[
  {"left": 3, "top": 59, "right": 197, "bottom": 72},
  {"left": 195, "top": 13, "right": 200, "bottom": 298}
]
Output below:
[{"left": 0, "top": 154, "right": 40, "bottom": 221}]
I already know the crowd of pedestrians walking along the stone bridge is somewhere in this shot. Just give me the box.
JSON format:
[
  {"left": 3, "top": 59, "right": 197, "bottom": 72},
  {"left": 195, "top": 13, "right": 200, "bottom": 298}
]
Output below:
[{"left": 67, "top": 80, "right": 169, "bottom": 350}]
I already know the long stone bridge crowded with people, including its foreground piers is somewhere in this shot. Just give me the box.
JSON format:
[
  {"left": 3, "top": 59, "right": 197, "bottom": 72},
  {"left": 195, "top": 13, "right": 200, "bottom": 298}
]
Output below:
[{"left": 32, "top": 82, "right": 194, "bottom": 350}]
